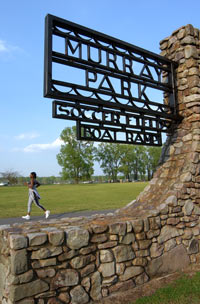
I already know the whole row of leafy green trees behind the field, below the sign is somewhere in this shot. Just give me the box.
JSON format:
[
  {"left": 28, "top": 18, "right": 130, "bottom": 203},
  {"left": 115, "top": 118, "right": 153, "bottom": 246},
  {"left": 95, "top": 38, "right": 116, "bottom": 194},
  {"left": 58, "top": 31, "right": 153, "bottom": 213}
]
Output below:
[{"left": 57, "top": 127, "right": 161, "bottom": 183}]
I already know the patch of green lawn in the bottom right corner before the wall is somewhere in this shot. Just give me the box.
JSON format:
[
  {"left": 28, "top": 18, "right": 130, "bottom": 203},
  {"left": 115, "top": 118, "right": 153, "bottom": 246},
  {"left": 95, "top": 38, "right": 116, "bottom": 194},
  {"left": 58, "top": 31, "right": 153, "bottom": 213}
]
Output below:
[{"left": 130, "top": 272, "right": 200, "bottom": 304}]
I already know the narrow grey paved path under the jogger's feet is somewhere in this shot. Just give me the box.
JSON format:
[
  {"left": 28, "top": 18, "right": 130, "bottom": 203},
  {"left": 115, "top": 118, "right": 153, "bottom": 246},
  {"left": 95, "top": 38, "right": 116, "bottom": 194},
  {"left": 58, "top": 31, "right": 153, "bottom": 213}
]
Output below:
[{"left": 0, "top": 210, "right": 115, "bottom": 225}]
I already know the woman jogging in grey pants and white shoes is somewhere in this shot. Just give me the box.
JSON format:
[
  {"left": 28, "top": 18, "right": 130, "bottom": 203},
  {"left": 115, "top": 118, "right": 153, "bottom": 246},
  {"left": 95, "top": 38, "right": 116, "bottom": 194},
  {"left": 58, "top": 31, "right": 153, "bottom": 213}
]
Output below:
[{"left": 22, "top": 172, "right": 50, "bottom": 220}]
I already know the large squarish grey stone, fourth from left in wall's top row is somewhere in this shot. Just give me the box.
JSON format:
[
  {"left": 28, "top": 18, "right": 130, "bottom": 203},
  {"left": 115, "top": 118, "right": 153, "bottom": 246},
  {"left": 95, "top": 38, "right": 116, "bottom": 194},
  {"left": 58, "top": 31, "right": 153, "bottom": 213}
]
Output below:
[{"left": 65, "top": 227, "right": 89, "bottom": 249}]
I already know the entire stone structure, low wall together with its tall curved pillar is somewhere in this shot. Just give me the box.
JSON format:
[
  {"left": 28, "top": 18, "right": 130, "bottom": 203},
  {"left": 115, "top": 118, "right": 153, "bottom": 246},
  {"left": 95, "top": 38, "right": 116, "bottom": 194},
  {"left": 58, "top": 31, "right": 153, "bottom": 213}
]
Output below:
[{"left": 0, "top": 25, "right": 200, "bottom": 304}]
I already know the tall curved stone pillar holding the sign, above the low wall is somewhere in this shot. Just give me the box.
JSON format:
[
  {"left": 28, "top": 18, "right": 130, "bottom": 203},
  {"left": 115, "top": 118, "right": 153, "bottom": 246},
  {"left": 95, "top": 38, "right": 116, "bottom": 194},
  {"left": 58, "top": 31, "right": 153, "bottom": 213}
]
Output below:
[{"left": 121, "top": 24, "right": 200, "bottom": 216}]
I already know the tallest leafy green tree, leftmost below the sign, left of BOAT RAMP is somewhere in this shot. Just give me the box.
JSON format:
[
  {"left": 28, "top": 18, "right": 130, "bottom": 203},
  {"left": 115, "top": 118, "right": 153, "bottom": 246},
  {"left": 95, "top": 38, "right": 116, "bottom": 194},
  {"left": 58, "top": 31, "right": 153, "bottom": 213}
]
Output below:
[{"left": 57, "top": 127, "right": 94, "bottom": 183}]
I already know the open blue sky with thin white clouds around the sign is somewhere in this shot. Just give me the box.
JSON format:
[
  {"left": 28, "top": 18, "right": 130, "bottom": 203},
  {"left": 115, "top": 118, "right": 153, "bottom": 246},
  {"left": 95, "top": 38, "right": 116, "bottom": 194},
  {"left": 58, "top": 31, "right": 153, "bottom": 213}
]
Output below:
[{"left": 0, "top": 0, "right": 200, "bottom": 176}]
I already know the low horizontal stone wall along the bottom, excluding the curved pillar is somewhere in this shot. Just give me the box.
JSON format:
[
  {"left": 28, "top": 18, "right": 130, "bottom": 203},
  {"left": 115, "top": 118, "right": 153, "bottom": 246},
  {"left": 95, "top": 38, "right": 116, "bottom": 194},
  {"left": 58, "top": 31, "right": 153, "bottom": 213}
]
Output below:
[{"left": 0, "top": 209, "right": 200, "bottom": 304}]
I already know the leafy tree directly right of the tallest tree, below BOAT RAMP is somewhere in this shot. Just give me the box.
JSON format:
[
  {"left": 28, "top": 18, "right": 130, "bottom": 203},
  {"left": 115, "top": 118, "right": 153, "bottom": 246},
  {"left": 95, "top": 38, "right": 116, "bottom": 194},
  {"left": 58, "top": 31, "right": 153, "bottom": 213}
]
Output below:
[{"left": 95, "top": 143, "right": 122, "bottom": 182}]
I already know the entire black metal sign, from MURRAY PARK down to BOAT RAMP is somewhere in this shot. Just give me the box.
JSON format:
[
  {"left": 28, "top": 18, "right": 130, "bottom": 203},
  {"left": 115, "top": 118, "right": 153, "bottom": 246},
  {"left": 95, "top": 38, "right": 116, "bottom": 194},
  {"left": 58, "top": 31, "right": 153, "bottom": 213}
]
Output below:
[{"left": 44, "top": 15, "right": 180, "bottom": 145}]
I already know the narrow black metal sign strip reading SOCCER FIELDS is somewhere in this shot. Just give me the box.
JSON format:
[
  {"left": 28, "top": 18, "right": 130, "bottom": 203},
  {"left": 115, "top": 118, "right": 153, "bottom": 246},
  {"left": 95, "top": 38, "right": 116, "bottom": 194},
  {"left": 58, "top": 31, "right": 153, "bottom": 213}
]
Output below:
[{"left": 53, "top": 100, "right": 170, "bottom": 133}]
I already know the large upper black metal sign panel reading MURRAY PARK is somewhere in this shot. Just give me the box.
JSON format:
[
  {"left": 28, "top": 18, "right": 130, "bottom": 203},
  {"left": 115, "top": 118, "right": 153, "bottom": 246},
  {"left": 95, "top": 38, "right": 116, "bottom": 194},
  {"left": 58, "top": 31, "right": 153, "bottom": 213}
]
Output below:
[{"left": 44, "top": 15, "right": 176, "bottom": 115}]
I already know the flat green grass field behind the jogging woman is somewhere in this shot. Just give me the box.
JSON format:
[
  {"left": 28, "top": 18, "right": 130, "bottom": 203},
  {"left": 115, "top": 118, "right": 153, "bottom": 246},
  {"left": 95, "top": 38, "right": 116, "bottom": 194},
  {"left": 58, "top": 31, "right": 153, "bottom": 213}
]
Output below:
[{"left": 0, "top": 182, "right": 147, "bottom": 218}]
